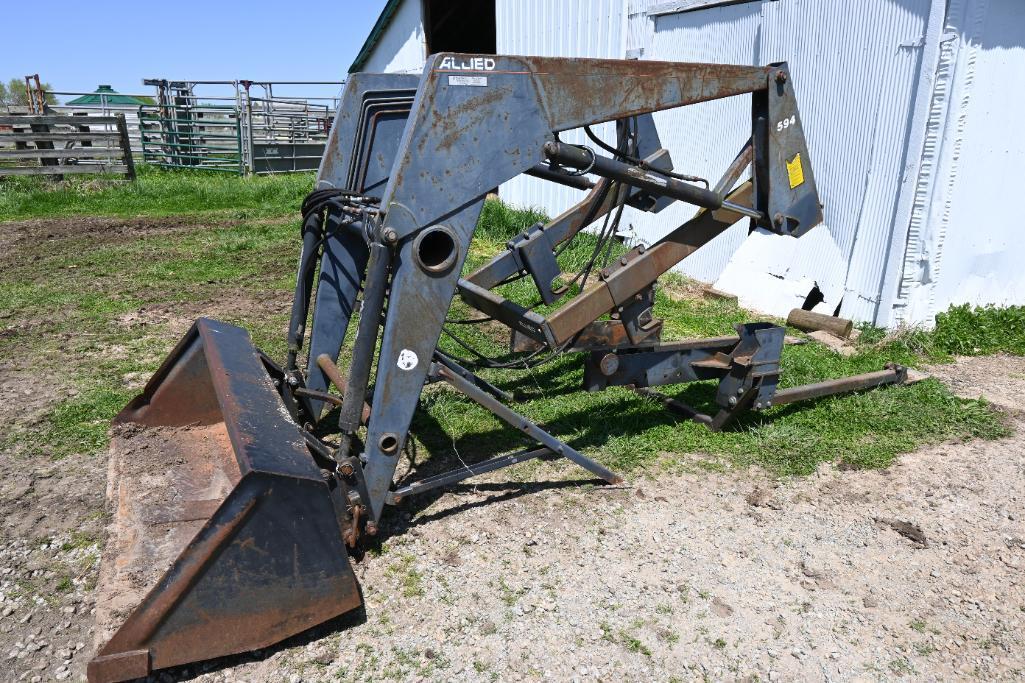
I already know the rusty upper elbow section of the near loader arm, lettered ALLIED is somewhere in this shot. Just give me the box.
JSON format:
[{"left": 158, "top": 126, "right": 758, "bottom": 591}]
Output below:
[{"left": 382, "top": 53, "right": 773, "bottom": 239}]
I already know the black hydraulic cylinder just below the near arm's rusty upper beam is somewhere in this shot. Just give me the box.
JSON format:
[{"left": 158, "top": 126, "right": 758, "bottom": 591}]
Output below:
[{"left": 544, "top": 142, "right": 723, "bottom": 209}]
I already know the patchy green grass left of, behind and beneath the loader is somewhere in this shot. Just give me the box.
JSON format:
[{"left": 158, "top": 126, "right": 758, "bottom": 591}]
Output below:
[{"left": 0, "top": 169, "right": 1008, "bottom": 477}]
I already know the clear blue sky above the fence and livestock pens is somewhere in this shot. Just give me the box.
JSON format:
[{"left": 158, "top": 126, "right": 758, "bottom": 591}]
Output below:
[{"left": 0, "top": 0, "right": 385, "bottom": 102}]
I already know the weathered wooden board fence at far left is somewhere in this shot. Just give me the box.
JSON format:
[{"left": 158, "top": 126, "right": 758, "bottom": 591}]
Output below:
[{"left": 0, "top": 114, "right": 135, "bottom": 179}]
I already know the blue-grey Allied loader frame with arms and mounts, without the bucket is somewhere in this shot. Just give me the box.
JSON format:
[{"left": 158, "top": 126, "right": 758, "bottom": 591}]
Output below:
[{"left": 285, "top": 54, "right": 903, "bottom": 536}]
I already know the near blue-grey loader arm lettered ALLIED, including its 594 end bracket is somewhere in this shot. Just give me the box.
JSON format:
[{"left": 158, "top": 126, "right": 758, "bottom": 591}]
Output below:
[{"left": 338, "top": 54, "right": 821, "bottom": 523}]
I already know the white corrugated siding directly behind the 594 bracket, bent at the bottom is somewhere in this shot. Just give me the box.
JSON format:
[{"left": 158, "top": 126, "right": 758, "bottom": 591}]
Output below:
[{"left": 716, "top": 0, "right": 932, "bottom": 320}]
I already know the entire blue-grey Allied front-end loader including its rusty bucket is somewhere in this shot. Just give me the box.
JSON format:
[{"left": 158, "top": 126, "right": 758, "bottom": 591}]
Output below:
[{"left": 88, "top": 54, "right": 906, "bottom": 683}]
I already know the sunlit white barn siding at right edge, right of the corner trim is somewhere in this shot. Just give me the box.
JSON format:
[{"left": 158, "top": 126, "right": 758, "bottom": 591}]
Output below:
[{"left": 899, "top": 0, "right": 1025, "bottom": 324}]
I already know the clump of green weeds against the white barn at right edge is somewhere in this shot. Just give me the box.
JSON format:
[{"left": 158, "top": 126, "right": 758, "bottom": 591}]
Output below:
[{"left": 933, "top": 304, "right": 1025, "bottom": 356}]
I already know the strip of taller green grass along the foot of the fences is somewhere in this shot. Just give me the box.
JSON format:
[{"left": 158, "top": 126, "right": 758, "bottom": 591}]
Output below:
[{"left": 0, "top": 165, "right": 313, "bottom": 220}]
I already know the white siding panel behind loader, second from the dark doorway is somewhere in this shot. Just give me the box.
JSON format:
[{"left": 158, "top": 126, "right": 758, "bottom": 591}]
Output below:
[{"left": 628, "top": 3, "right": 761, "bottom": 282}]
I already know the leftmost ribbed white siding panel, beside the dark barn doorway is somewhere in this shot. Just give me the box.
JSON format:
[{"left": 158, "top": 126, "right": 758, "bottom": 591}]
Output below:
[{"left": 495, "top": 0, "right": 626, "bottom": 216}]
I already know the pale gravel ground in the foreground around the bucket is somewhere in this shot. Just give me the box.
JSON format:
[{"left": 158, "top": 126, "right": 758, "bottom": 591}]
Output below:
[{"left": 0, "top": 357, "right": 1025, "bottom": 682}]
